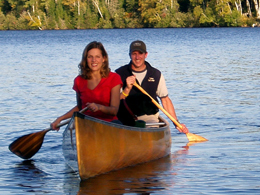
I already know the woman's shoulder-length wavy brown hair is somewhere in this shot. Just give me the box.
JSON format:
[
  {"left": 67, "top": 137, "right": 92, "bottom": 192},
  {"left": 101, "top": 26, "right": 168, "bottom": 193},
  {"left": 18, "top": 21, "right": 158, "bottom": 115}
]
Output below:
[{"left": 79, "top": 41, "right": 110, "bottom": 79}]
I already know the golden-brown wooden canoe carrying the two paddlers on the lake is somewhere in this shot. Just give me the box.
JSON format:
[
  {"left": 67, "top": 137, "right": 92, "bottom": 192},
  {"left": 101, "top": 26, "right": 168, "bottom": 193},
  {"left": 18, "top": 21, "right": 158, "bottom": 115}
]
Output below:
[{"left": 62, "top": 112, "right": 171, "bottom": 180}]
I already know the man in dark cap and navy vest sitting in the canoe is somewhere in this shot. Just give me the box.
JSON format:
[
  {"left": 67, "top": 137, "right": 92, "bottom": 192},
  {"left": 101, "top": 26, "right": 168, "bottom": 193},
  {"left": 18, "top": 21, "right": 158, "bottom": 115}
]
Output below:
[{"left": 115, "top": 40, "right": 189, "bottom": 133}]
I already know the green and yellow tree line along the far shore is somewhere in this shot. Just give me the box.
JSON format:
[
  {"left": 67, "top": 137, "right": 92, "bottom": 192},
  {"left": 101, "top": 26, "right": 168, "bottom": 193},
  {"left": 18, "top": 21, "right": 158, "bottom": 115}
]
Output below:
[{"left": 0, "top": 0, "right": 260, "bottom": 30}]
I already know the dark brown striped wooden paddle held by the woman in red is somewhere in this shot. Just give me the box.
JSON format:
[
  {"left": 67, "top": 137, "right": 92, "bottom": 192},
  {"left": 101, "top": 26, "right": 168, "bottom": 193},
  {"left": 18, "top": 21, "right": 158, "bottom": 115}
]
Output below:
[{"left": 9, "top": 107, "right": 87, "bottom": 159}]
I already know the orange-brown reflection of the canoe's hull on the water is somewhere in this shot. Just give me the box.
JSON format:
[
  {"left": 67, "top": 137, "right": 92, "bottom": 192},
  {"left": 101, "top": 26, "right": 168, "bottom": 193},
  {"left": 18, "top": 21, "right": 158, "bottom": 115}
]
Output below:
[{"left": 78, "top": 155, "right": 175, "bottom": 195}]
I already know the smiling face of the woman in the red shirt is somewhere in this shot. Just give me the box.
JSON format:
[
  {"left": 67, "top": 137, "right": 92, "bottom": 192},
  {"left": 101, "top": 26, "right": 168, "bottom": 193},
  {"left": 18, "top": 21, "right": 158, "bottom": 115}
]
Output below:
[{"left": 87, "top": 48, "right": 105, "bottom": 71}]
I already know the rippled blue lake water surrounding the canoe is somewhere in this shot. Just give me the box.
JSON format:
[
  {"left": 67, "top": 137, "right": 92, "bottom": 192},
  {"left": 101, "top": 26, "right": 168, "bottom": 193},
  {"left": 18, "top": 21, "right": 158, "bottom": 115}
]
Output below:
[{"left": 0, "top": 28, "right": 260, "bottom": 195}]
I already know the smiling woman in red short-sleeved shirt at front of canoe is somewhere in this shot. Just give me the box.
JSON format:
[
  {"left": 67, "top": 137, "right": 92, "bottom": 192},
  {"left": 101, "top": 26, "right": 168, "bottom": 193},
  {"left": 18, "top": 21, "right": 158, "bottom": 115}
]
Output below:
[{"left": 51, "top": 41, "right": 122, "bottom": 130}]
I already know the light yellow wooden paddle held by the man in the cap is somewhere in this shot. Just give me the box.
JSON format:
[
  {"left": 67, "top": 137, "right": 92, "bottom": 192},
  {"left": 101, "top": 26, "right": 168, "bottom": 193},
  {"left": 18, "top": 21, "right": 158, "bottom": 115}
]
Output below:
[{"left": 134, "top": 82, "right": 207, "bottom": 142}]
